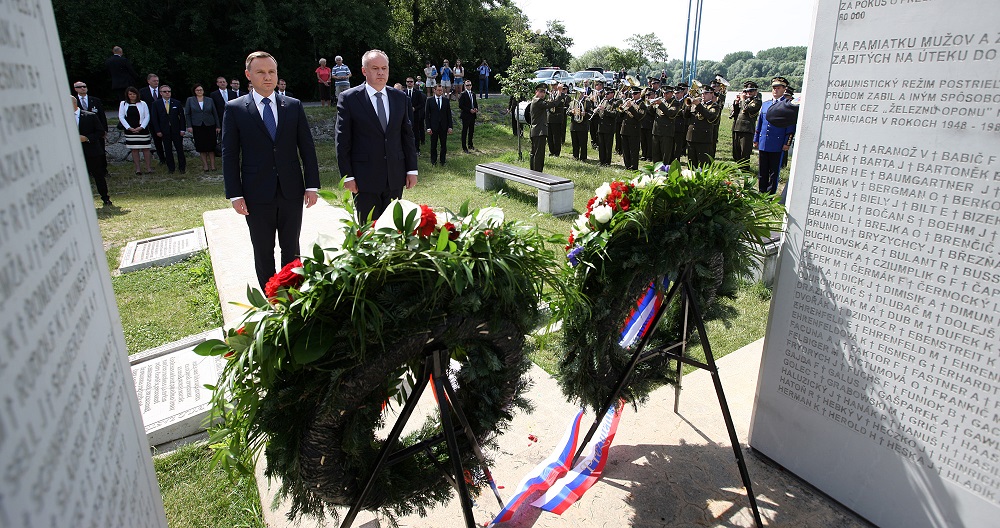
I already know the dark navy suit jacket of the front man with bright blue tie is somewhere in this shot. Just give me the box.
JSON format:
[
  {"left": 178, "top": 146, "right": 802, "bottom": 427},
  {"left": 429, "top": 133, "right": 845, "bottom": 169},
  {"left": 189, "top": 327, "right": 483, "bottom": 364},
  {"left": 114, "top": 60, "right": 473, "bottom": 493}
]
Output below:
[{"left": 222, "top": 94, "right": 320, "bottom": 203}]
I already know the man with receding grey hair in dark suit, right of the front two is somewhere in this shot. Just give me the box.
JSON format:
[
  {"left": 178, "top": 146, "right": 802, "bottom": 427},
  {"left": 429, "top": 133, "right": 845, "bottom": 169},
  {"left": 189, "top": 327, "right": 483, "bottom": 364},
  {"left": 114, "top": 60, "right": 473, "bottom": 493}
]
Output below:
[{"left": 337, "top": 50, "right": 417, "bottom": 222}]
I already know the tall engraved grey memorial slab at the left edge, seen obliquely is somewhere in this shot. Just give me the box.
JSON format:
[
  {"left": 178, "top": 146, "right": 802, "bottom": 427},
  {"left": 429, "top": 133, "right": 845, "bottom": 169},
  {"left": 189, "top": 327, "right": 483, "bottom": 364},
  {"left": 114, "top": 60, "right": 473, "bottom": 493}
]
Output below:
[{"left": 0, "top": 2, "right": 167, "bottom": 528}]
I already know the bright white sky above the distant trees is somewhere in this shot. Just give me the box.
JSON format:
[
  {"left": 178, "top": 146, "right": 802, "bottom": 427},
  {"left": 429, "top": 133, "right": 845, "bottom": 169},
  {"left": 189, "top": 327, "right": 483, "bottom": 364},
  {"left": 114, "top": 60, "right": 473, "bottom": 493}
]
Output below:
[{"left": 514, "top": 0, "right": 816, "bottom": 63}]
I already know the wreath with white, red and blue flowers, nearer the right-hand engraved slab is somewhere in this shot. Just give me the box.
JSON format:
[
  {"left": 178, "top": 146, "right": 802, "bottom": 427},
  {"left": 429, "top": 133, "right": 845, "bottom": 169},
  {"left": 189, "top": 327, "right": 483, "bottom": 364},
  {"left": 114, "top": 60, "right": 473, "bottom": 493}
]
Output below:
[{"left": 558, "top": 162, "right": 783, "bottom": 411}]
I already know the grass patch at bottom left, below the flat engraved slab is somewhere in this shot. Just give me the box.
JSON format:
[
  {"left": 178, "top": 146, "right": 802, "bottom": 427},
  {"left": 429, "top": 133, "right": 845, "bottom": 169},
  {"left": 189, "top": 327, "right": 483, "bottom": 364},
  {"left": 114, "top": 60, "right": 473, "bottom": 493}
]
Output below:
[{"left": 153, "top": 444, "right": 265, "bottom": 528}]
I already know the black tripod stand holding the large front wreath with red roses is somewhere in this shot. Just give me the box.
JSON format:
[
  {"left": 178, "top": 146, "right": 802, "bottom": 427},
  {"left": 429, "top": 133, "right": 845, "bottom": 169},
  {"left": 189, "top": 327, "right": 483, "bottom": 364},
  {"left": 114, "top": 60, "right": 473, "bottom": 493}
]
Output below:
[{"left": 340, "top": 347, "right": 504, "bottom": 528}]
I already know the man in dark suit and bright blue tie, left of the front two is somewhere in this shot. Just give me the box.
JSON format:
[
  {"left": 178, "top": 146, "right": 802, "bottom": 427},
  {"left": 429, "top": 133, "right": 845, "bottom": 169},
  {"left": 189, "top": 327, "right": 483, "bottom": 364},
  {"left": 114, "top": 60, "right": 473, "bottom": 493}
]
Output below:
[{"left": 222, "top": 51, "right": 319, "bottom": 290}]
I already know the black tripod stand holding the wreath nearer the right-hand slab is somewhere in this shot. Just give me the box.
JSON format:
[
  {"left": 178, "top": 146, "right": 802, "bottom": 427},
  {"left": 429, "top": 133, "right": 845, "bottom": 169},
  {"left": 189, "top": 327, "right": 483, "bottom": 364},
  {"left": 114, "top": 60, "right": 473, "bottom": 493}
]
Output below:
[{"left": 572, "top": 266, "right": 764, "bottom": 528}]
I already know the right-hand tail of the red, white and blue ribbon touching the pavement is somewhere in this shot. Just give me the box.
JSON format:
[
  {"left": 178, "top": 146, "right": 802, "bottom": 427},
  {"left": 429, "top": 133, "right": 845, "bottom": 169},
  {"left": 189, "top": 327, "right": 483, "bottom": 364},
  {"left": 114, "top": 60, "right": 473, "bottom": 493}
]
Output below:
[{"left": 531, "top": 400, "right": 625, "bottom": 515}]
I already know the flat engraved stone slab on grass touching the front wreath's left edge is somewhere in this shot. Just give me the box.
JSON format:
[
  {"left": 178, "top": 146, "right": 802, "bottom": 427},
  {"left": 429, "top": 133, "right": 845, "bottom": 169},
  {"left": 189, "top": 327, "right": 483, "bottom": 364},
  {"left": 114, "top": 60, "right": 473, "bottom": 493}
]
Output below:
[{"left": 129, "top": 328, "right": 225, "bottom": 446}]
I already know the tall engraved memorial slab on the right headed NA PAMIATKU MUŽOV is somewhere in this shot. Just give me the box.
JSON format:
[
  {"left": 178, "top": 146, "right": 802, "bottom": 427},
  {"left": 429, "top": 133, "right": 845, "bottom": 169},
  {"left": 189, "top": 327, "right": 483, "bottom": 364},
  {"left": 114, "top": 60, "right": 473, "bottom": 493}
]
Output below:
[{"left": 750, "top": 0, "right": 1000, "bottom": 527}]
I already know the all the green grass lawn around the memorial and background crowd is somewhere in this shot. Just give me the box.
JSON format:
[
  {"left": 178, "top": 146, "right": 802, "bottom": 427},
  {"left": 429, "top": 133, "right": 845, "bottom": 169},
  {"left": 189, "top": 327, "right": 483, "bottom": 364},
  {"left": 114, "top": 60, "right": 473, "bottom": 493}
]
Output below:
[{"left": 94, "top": 98, "right": 768, "bottom": 527}]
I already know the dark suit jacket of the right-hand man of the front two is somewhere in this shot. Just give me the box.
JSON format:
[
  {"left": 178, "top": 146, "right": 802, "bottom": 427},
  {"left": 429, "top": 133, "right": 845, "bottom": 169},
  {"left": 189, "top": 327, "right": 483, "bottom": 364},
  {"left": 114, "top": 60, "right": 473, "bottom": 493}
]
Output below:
[{"left": 337, "top": 84, "right": 416, "bottom": 193}]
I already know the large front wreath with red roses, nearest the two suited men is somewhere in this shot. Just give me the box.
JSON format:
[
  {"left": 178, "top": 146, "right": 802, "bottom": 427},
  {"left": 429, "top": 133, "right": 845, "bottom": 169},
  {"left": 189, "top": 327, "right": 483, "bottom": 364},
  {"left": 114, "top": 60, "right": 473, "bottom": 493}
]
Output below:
[{"left": 197, "top": 194, "right": 563, "bottom": 518}]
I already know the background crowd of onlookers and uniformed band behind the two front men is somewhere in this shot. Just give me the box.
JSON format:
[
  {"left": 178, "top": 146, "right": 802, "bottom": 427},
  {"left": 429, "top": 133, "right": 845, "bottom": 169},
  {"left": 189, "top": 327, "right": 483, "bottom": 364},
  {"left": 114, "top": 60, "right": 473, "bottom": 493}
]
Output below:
[{"left": 84, "top": 46, "right": 794, "bottom": 213}]
